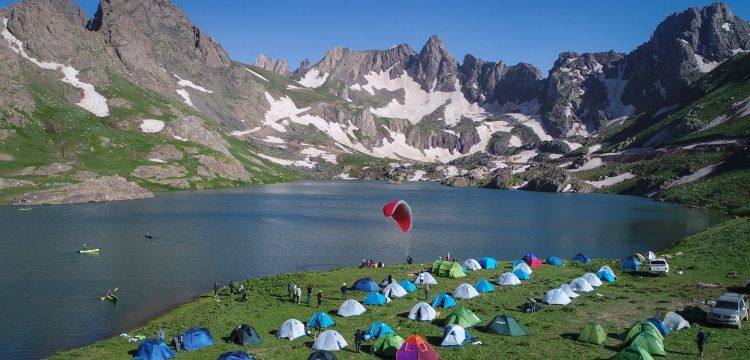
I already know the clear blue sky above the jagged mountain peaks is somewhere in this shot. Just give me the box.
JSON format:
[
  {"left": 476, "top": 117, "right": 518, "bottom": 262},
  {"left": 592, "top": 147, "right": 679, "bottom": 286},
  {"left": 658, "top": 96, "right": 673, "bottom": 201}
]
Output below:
[{"left": 0, "top": 0, "right": 750, "bottom": 74}]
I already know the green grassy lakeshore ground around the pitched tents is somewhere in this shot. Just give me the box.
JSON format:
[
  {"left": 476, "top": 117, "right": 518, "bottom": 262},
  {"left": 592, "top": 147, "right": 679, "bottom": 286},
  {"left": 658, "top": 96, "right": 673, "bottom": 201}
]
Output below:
[{"left": 52, "top": 218, "right": 750, "bottom": 359}]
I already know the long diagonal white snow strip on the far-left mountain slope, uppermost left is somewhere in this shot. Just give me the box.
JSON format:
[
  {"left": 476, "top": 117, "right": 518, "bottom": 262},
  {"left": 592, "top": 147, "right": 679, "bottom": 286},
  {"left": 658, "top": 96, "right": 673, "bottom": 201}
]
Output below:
[{"left": 2, "top": 17, "right": 109, "bottom": 117}]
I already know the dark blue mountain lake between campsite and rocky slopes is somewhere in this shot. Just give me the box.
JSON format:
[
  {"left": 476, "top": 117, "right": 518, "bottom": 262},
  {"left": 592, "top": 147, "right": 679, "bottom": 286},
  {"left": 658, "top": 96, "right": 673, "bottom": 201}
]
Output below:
[{"left": 0, "top": 181, "right": 725, "bottom": 359}]
